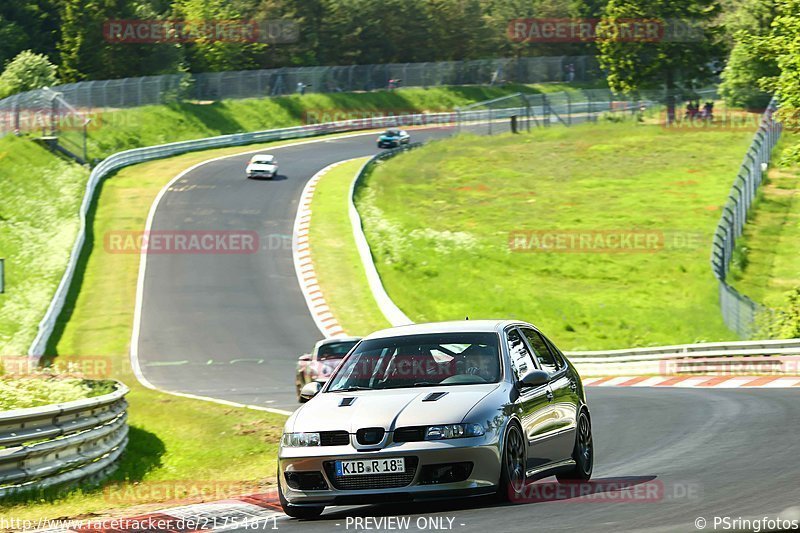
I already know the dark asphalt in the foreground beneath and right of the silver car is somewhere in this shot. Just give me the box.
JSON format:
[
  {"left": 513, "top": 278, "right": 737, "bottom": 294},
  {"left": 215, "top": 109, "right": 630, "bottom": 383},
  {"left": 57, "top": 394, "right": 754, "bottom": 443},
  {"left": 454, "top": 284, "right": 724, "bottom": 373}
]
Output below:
[{"left": 250, "top": 387, "right": 800, "bottom": 533}]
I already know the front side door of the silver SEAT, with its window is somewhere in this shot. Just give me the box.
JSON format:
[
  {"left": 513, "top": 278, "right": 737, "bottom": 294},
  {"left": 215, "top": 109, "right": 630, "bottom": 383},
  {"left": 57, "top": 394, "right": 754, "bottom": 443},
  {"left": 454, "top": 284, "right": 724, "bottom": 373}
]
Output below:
[{"left": 505, "top": 327, "right": 554, "bottom": 470}]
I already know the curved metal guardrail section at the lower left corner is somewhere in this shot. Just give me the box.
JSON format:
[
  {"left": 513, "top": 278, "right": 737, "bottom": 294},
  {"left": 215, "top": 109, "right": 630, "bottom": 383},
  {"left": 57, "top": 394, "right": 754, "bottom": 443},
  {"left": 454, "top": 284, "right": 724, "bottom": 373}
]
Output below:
[{"left": 0, "top": 383, "right": 128, "bottom": 498}]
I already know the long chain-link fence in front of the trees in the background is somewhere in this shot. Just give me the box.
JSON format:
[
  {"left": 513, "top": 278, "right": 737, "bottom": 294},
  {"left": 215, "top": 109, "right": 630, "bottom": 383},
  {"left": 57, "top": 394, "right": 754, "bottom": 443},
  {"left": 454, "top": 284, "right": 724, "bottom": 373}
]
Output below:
[{"left": 0, "top": 56, "right": 601, "bottom": 136}]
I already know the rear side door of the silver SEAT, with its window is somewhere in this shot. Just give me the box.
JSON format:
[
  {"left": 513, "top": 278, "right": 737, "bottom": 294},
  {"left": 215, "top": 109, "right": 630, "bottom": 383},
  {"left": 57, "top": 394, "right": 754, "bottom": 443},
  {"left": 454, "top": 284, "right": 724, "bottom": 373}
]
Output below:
[{"left": 521, "top": 328, "right": 578, "bottom": 461}]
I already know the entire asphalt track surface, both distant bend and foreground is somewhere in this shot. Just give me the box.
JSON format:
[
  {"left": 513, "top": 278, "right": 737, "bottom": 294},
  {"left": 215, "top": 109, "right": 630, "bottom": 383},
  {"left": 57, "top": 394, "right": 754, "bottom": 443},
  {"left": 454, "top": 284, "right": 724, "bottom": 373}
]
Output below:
[{"left": 138, "top": 123, "right": 800, "bottom": 532}]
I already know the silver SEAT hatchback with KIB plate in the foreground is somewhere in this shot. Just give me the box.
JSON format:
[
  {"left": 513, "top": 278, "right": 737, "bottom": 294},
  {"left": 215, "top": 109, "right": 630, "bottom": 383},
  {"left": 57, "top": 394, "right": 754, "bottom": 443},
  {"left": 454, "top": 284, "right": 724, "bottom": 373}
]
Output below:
[{"left": 278, "top": 320, "right": 594, "bottom": 518}]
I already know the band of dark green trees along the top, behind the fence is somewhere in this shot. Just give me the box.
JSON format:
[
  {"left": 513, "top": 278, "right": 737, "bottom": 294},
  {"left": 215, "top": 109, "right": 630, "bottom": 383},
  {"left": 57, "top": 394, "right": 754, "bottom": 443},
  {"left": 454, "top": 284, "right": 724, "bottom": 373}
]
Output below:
[{"left": 0, "top": 0, "right": 797, "bottom": 97}]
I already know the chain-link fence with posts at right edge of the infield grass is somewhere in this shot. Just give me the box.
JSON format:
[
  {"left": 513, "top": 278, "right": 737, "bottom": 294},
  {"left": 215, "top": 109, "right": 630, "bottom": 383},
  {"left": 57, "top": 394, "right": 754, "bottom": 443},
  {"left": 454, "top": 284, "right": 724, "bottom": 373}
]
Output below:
[{"left": 711, "top": 99, "right": 782, "bottom": 337}]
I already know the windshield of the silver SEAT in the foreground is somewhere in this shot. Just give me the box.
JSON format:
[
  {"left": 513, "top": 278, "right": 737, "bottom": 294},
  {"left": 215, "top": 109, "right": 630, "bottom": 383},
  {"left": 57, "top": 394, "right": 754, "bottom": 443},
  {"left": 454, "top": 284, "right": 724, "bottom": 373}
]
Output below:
[{"left": 327, "top": 333, "right": 500, "bottom": 392}]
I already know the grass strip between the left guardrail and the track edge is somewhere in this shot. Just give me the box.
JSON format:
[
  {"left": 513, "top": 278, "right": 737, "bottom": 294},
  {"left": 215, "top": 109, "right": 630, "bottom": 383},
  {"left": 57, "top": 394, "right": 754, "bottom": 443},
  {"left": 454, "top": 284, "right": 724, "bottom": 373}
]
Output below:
[{"left": 0, "top": 141, "right": 310, "bottom": 518}]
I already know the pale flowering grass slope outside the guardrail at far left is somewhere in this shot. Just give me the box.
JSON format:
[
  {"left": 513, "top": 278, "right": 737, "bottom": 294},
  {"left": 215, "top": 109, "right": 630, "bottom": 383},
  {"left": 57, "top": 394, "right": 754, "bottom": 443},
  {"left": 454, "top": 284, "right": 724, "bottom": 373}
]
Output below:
[{"left": 0, "top": 135, "right": 89, "bottom": 355}]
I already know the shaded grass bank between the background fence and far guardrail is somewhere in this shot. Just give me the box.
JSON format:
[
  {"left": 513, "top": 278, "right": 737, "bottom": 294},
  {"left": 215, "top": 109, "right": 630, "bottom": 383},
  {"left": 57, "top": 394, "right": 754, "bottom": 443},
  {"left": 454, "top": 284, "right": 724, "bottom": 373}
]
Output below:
[{"left": 83, "top": 84, "right": 600, "bottom": 157}]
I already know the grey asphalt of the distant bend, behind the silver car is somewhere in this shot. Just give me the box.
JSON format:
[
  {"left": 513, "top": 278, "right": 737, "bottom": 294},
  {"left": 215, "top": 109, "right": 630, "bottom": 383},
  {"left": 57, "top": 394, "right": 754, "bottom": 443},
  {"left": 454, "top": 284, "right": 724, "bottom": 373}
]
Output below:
[{"left": 138, "top": 127, "right": 462, "bottom": 410}]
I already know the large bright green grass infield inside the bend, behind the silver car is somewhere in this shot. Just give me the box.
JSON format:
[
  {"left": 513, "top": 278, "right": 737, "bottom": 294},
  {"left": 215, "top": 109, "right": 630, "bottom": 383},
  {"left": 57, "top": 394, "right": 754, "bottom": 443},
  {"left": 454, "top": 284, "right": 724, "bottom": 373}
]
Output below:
[{"left": 357, "top": 123, "right": 752, "bottom": 349}]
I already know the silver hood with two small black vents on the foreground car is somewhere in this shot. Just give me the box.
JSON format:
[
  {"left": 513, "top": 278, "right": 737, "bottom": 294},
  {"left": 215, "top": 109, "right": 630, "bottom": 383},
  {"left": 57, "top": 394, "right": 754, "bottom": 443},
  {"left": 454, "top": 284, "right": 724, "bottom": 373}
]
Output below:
[{"left": 286, "top": 383, "right": 499, "bottom": 433}]
